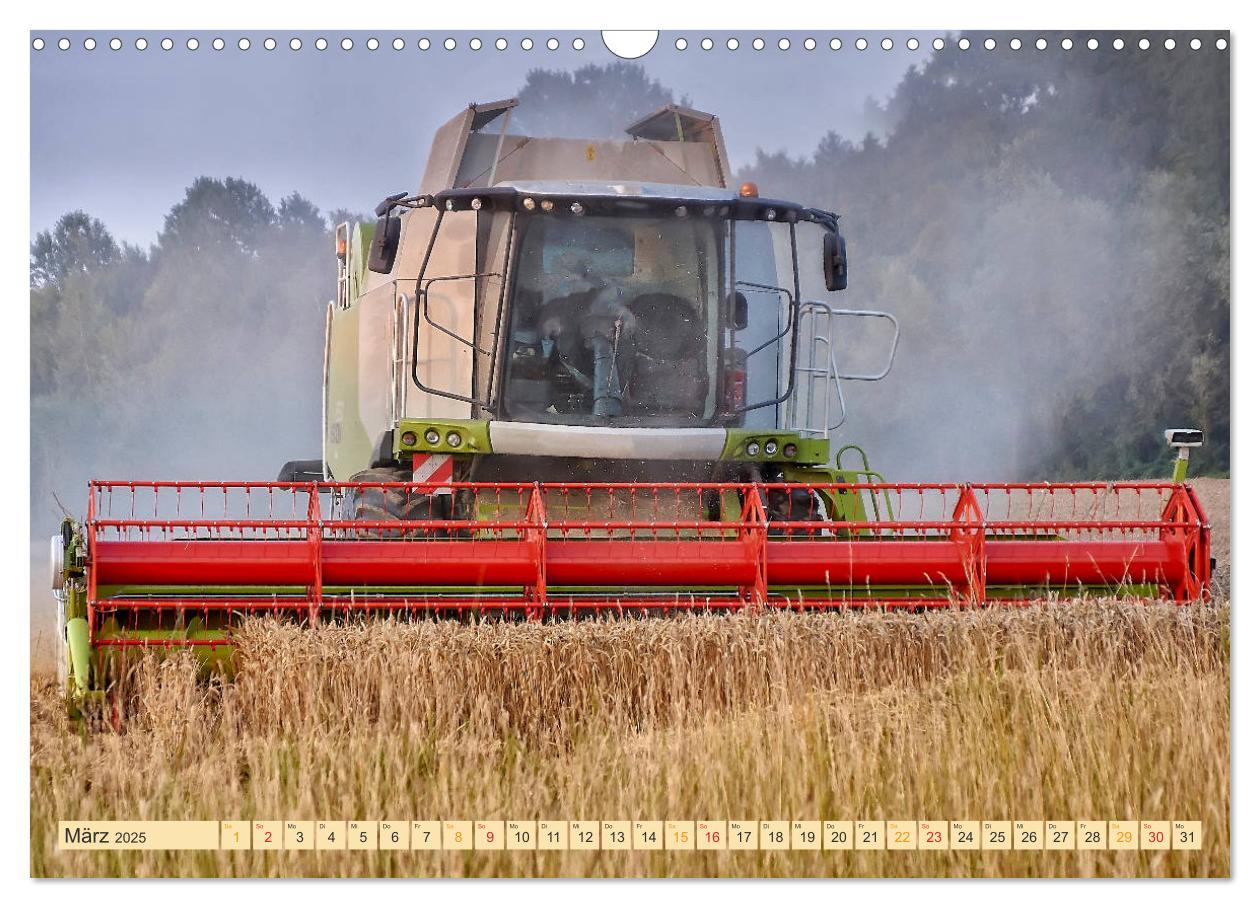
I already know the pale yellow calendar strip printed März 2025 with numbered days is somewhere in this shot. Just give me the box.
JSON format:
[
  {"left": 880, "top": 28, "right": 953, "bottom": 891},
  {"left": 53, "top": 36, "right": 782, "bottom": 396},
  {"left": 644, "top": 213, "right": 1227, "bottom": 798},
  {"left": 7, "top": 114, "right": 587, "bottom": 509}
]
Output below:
[{"left": 57, "top": 820, "right": 1203, "bottom": 851}]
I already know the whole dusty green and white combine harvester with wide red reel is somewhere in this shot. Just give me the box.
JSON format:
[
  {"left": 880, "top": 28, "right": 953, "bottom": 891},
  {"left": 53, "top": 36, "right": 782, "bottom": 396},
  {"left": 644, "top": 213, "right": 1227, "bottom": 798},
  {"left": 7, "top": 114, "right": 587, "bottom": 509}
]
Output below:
[{"left": 53, "top": 101, "right": 1211, "bottom": 699}]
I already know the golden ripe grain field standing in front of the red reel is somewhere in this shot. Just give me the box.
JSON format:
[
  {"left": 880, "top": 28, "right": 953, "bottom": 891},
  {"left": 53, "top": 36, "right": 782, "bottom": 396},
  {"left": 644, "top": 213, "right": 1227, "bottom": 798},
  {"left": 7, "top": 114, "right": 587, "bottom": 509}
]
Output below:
[{"left": 32, "top": 601, "right": 1229, "bottom": 877}]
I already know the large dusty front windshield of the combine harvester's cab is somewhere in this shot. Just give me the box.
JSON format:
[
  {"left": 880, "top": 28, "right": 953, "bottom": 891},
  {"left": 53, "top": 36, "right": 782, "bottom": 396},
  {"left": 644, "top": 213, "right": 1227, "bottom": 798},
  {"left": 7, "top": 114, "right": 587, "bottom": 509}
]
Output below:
[{"left": 503, "top": 215, "right": 725, "bottom": 426}]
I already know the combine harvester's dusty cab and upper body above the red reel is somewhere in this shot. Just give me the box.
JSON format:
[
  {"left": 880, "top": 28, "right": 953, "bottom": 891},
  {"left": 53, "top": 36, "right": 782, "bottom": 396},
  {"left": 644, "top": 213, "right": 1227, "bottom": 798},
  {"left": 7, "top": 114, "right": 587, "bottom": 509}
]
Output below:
[{"left": 309, "top": 101, "right": 898, "bottom": 505}]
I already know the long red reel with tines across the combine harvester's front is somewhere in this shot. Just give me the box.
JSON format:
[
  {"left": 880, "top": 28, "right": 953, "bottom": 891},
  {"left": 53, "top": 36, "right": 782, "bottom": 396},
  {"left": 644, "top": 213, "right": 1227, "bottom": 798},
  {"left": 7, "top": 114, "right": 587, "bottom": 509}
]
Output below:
[{"left": 88, "top": 482, "right": 1210, "bottom": 634}]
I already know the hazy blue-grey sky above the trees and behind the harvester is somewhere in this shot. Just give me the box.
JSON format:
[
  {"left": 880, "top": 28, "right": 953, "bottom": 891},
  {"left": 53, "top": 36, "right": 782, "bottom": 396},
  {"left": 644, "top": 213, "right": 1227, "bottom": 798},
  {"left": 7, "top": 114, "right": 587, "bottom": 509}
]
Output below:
[{"left": 30, "top": 31, "right": 934, "bottom": 246}]
